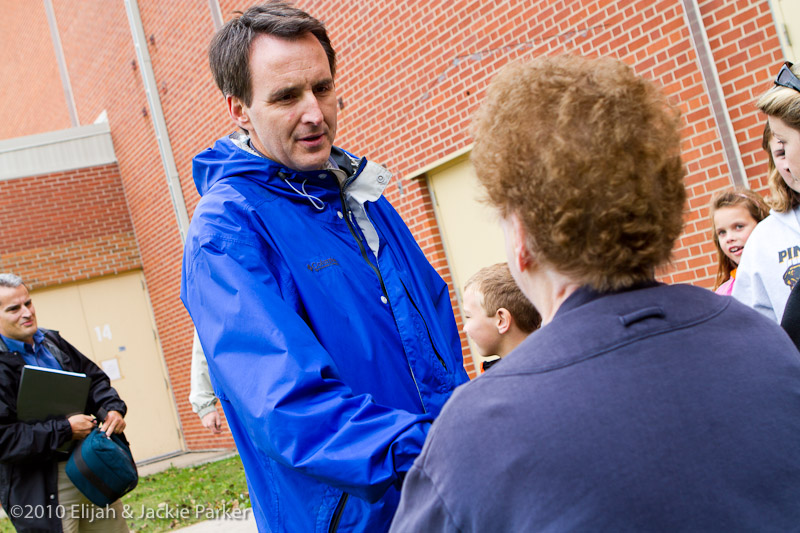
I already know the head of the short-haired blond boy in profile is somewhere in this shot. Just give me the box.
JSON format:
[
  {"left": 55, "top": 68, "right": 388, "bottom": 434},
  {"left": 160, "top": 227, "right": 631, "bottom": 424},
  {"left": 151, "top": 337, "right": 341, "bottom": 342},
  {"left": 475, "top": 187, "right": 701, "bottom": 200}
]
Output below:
[{"left": 463, "top": 263, "right": 542, "bottom": 370}]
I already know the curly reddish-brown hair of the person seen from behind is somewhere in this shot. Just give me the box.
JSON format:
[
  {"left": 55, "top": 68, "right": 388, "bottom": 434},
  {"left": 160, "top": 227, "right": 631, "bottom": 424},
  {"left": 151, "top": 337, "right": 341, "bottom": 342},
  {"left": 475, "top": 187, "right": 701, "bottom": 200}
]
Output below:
[{"left": 472, "top": 55, "right": 686, "bottom": 291}]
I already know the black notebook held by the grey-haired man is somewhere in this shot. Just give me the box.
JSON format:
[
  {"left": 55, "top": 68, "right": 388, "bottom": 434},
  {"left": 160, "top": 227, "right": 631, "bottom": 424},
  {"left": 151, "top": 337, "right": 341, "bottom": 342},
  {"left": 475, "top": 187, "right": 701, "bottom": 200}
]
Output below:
[{"left": 17, "top": 365, "right": 92, "bottom": 422}]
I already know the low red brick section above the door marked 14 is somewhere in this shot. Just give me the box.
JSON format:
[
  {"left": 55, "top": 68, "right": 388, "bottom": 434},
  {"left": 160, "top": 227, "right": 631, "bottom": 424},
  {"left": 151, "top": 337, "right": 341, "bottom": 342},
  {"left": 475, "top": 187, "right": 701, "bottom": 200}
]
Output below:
[{"left": 0, "top": 164, "right": 141, "bottom": 288}]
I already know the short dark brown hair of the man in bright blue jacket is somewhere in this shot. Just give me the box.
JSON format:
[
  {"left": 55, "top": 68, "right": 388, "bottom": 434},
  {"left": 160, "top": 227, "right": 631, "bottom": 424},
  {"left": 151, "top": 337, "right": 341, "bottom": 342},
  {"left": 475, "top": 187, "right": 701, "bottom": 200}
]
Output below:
[{"left": 208, "top": 1, "right": 336, "bottom": 107}]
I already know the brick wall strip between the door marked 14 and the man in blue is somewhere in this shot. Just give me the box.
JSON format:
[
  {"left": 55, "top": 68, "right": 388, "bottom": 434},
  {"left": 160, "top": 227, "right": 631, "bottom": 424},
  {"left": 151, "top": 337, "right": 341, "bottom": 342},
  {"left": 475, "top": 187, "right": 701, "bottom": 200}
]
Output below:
[{"left": 45, "top": 0, "right": 233, "bottom": 449}]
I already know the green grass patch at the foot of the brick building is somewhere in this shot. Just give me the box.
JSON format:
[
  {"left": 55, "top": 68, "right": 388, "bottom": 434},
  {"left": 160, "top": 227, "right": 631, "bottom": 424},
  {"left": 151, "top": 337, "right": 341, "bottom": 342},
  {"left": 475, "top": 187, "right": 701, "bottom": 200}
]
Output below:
[{"left": 0, "top": 455, "right": 250, "bottom": 533}]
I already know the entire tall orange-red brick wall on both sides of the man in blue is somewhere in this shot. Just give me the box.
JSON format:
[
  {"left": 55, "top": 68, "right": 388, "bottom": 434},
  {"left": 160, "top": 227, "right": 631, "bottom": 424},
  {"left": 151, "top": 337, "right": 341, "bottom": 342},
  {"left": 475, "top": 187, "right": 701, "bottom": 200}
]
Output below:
[{"left": 0, "top": 0, "right": 781, "bottom": 448}]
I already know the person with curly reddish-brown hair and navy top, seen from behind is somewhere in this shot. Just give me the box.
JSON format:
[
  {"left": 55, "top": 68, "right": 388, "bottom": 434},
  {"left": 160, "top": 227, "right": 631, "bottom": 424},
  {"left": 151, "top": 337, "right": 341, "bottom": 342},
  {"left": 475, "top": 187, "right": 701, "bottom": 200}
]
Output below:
[{"left": 392, "top": 56, "right": 800, "bottom": 532}]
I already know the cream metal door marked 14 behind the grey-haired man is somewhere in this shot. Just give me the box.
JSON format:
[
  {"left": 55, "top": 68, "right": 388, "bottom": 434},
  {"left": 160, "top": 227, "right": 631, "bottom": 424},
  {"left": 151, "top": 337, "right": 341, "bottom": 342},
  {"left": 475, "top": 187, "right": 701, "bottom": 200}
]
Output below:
[{"left": 32, "top": 271, "right": 183, "bottom": 461}]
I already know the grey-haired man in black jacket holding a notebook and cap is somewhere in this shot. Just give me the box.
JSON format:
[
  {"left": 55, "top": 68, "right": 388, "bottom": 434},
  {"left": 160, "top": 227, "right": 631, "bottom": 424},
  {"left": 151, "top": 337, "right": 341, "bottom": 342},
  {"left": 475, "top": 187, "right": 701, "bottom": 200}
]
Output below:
[{"left": 0, "top": 274, "right": 128, "bottom": 532}]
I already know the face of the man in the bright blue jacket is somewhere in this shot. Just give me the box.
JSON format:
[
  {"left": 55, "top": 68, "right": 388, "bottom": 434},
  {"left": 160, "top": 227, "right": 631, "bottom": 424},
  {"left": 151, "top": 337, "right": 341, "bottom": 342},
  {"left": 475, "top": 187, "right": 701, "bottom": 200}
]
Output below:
[{"left": 228, "top": 33, "right": 338, "bottom": 170}]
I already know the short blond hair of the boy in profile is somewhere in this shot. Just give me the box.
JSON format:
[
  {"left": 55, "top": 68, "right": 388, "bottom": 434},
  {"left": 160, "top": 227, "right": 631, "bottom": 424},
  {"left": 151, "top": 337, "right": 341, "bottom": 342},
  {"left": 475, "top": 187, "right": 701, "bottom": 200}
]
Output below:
[{"left": 464, "top": 263, "right": 542, "bottom": 333}]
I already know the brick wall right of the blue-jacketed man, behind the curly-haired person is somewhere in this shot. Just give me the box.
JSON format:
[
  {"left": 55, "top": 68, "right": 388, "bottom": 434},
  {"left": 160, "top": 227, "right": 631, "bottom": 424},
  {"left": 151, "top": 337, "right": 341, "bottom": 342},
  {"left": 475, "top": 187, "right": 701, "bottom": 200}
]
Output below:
[{"left": 316, "top": 0, "right": 781, "bottom": 287}]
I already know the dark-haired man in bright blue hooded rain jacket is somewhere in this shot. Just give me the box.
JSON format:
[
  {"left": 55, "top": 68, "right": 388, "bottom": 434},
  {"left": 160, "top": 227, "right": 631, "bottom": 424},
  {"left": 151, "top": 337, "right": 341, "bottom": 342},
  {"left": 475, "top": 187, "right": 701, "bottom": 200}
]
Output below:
[{"left": 181, "top": 2, "right": 467, "bottom": 532}]
